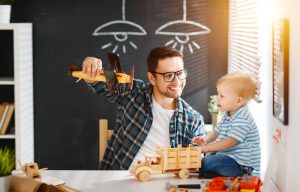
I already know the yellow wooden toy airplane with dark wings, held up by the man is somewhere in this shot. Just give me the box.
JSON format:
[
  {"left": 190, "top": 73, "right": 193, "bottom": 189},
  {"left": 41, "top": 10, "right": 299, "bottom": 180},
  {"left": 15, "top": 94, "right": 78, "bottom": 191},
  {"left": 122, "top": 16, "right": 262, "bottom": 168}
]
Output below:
[{"left": 69, "top": 53, "right": 134, "bottom": 91}]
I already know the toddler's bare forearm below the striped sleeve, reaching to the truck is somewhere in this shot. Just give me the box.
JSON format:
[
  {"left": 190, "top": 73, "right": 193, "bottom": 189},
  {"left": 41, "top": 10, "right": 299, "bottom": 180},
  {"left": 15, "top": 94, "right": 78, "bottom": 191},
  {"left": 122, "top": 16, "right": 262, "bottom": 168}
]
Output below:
[{"left": 201, "top": 137, "right": 237, "bottom": 153}]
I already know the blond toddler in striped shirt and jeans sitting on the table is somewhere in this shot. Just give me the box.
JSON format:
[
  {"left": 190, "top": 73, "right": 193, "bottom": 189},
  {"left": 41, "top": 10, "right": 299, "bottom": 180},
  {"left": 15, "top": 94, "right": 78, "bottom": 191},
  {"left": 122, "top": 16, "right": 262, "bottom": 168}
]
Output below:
[{"left": 192, "top": 72, "right": 260, "bottom": 177}]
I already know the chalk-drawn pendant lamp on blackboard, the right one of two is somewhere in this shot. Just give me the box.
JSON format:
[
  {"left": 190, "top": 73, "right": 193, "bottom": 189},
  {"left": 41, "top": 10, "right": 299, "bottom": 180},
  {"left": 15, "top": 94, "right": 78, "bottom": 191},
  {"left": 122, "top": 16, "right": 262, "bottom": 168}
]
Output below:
[{"left": 155, "top": 0, "right": 211, "bottom": 53}]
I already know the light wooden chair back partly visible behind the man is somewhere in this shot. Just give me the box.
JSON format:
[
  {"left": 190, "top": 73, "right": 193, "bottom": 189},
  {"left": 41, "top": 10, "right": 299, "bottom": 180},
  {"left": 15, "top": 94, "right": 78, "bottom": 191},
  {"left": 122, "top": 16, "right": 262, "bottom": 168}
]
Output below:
[{"left": 99, "top": 119, "right": 113, "bottom": 161}]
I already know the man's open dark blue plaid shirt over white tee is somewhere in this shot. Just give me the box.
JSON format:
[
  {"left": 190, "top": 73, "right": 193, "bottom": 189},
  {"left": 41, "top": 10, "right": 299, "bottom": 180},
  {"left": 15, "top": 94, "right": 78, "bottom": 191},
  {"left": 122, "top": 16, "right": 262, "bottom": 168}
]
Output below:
[{"left": 89, "top": 80, "right": 204, "bottom": 170}]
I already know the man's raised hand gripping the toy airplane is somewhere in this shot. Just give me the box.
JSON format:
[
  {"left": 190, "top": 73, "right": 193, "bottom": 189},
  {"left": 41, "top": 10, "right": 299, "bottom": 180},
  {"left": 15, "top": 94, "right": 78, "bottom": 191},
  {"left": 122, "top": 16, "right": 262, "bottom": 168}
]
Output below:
[{"left": 82, "top": 57, "right": 103, "bottom": 78}]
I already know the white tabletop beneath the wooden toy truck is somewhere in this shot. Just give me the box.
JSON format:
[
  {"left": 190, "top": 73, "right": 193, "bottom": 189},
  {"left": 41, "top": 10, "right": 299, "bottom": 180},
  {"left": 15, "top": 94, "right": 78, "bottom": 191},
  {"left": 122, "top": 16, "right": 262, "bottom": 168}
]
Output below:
[{"left": 42, "top": 170, "right": 208, "bottom": 192}]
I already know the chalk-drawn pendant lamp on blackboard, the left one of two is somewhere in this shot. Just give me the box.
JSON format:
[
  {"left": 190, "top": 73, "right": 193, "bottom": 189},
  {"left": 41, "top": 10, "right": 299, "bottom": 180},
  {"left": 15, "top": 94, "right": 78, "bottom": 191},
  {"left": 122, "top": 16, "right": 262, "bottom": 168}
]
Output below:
[{"left": 93, "top": 0, "right": 147, "bottom": 53}]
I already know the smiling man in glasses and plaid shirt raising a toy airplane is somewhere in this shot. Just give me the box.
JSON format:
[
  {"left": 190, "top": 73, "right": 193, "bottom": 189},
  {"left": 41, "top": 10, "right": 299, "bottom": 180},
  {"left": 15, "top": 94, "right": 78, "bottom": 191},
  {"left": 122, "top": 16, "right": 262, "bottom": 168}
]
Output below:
[{"left": 83, "top": 47, "right": 204, "bottom": 170}]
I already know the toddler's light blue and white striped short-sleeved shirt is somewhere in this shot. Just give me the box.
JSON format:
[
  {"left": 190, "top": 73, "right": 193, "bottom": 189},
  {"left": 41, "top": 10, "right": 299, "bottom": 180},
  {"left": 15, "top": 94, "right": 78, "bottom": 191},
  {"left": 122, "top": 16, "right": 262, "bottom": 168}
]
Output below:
[{"left": 215, "top": 105, "right": 260, "bottom": 173}]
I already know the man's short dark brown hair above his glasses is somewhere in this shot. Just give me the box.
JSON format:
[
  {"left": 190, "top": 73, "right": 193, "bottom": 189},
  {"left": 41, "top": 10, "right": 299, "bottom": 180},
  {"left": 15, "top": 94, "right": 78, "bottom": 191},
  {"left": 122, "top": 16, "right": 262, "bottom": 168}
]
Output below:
[{"left": 147, "top": 47, "right": 182, "bottom": 72}]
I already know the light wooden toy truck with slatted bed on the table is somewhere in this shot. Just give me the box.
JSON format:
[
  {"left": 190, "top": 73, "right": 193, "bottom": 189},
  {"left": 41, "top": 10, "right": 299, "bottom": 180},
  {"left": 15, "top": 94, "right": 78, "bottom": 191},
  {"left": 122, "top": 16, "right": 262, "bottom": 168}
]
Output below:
[{"left": 130, "top": 145, "right": 201, "bottom": 181}]
